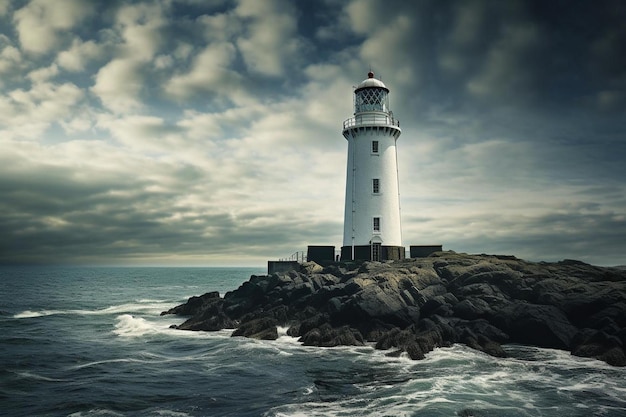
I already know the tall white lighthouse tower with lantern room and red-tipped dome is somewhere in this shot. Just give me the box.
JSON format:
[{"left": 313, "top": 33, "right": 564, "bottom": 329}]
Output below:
[{"left": 341, "top": 71, "right": 405, "bottom": 261}]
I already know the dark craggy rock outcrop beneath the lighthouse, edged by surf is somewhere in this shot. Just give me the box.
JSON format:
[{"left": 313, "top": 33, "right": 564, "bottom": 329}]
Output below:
[{"left": 162, "top": 252, "right": 626, "bottom": 366}]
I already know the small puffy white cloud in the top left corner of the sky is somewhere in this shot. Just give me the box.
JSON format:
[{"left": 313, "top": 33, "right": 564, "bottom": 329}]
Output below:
[{"left": 13, "top": 0, "right": 93, "bottom": 54}]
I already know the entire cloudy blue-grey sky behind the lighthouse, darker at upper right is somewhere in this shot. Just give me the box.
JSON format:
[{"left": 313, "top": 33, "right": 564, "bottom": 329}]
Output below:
[{"left": 0, "top": 0, "right": 626, "bottom": 266}]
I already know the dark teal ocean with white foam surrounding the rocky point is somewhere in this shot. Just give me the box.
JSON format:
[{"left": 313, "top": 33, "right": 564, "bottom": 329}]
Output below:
[{"left": 0, "top": 267, "right": 626, "bottom": 417}]
